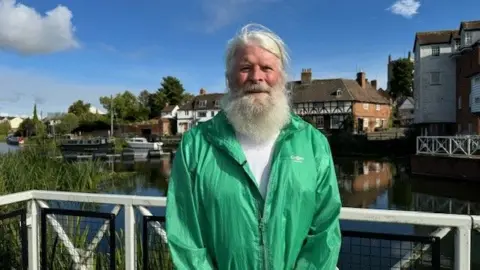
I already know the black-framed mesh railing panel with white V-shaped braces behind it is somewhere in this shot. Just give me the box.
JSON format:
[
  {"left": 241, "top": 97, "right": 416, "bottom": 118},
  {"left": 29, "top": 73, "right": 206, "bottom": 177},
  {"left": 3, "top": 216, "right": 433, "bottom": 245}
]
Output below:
[{"left": 40, "top": 208, "right": 116, "bottom": 270}]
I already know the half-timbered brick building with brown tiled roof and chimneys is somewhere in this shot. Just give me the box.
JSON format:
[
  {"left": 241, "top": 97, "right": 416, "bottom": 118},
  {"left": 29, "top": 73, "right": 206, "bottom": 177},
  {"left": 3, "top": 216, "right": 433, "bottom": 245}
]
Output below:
[{"left": 289, "top": 69, "right": 391, "bottom": 133}]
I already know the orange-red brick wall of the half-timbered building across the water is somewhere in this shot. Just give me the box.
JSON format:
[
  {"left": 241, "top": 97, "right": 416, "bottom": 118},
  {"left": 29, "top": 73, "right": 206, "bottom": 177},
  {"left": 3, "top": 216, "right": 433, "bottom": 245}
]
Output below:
[{"left": 353, "top": 102, "right": 392, "bottom": 132}]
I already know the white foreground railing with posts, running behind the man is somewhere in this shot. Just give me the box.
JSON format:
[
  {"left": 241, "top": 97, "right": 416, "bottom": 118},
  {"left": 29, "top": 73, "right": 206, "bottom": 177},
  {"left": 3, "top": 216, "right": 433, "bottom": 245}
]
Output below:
[{"left": 0, "top": 190, "right": 480, "bottom": 270}]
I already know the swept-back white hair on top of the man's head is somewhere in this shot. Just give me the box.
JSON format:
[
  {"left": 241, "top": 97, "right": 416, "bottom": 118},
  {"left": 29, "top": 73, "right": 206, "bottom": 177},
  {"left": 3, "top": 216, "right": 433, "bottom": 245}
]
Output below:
[{"left": 225, "top": 23, "right": 290, "bottom": 80}]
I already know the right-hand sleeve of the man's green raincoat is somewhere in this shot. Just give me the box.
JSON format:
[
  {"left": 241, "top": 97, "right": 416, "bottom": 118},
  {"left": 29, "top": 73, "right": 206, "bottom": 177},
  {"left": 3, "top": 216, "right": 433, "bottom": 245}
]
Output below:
[{"left": 296, "top": 142, "right": 342, "bottom": 270}]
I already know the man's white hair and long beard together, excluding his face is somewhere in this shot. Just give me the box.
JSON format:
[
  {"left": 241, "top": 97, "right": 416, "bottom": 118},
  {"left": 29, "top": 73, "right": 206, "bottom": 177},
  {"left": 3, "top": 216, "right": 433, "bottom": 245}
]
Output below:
[{"left": 221, "top": 24, "right": 290, "bottom": 142}]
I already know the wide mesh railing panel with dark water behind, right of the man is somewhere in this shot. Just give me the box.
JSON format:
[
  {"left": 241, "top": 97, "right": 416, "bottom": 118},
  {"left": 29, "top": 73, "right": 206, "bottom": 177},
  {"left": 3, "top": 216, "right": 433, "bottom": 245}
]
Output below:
[{"left": 338, "top": 231, "right": 440, "bottom": 270}]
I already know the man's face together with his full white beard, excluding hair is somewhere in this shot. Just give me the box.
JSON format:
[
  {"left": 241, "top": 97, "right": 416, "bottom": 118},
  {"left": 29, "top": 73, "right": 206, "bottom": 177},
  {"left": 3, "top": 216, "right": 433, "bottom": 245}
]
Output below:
[{"left": 222, "top": 45, "right": 290, "bottom": 142}]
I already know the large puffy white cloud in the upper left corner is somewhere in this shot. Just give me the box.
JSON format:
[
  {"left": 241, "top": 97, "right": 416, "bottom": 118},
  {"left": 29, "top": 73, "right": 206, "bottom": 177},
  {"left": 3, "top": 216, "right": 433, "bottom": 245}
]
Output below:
[{"left": 0, "top": 0, "right": 80, "bottom": 54}]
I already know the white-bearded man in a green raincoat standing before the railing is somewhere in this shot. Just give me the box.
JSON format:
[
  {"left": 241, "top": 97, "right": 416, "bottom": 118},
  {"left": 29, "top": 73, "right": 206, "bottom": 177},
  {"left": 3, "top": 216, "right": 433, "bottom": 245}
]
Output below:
[{"left": 166, "top": 25, "right": 341, "bottom": 270}]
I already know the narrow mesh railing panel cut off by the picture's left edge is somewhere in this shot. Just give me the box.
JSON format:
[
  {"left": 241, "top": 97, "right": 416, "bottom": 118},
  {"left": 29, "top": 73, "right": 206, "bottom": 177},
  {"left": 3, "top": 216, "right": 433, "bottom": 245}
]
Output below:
[{"left": 0, "top": 209, "right": 28, "bottom": 270}]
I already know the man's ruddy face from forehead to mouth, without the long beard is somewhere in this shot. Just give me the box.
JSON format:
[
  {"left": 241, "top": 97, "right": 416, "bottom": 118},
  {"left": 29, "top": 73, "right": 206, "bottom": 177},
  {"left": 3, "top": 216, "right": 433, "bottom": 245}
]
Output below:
[{"left": 231, "top": 45, "right": 282, "bottom": 103}]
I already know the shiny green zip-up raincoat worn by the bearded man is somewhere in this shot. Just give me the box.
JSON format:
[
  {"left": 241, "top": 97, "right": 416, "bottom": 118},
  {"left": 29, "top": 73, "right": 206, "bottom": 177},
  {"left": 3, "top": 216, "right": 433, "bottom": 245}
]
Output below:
[{"left": 166, "top": 112, "right": 341, "bottom": 270}]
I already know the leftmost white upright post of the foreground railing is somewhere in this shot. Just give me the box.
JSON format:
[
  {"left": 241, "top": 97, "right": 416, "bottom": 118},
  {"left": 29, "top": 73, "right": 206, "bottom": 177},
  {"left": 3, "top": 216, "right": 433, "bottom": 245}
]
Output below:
[{"left": 27, "top": 199, "right": 40, "bottom": 270}]
